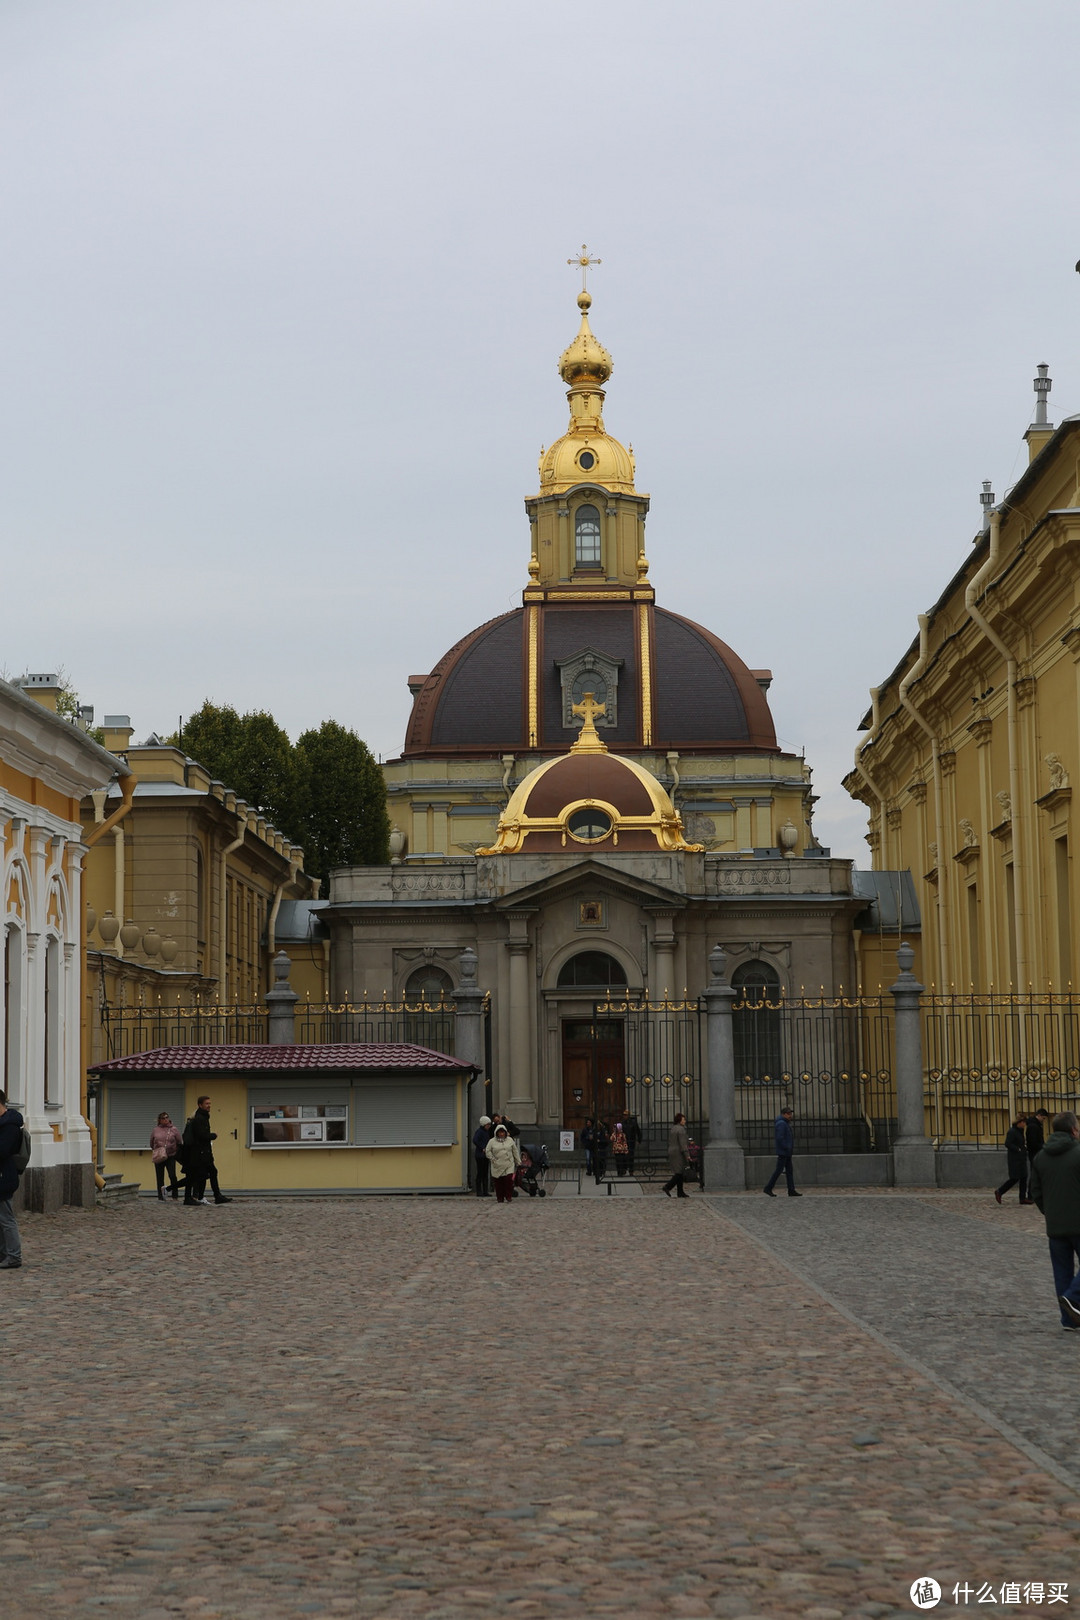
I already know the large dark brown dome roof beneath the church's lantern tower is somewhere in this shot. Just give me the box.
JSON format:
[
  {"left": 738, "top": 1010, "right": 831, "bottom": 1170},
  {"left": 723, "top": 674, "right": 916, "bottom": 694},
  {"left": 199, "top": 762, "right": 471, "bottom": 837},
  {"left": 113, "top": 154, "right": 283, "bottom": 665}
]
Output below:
[{"left": 403, "top": 603, "right": 777, "bottom": 758}]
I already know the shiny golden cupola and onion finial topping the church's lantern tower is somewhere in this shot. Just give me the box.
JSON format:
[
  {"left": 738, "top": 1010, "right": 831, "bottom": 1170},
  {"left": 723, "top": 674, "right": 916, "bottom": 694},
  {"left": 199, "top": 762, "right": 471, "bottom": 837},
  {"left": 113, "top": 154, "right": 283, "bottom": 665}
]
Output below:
[{"left": 539, "top": 292, "right": 635, "bottom": 496}]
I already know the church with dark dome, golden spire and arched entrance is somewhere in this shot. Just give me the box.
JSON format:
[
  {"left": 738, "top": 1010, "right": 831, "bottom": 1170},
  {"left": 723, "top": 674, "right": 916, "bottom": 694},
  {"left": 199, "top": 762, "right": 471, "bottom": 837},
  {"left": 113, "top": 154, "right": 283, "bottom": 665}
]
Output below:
[{"left": 321, "top": 292, "right": 866, "bottom": 1131}]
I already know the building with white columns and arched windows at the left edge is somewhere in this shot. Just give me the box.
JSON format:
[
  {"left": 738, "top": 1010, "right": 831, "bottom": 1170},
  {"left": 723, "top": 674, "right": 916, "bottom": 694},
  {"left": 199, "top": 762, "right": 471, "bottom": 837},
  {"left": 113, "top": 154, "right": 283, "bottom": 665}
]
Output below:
[{"left": 0, "top": 676, "right": 130, "bottom": 1209}]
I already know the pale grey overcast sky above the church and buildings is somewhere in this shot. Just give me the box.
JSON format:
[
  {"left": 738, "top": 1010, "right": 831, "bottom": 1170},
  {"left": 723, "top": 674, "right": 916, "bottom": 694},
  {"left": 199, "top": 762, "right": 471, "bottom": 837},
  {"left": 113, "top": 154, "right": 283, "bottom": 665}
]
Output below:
[{"left": 0, "top": 0, "right": 1080, "bottom": 865}]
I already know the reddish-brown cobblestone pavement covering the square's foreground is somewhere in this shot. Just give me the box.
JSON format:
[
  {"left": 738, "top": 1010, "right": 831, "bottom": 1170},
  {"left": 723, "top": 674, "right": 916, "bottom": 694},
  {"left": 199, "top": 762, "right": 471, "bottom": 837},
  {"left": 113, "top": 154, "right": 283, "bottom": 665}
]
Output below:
[{"left": 0, "top": 1192, "right": 1080, "bottom": 1620}]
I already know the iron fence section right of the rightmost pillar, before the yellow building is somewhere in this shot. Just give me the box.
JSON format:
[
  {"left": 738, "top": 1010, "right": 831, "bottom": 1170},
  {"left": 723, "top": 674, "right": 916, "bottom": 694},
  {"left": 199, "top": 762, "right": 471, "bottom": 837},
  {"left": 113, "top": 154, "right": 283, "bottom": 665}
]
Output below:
[{"left": 923, "top": 990, "right": 1080, "bottom": 1149}]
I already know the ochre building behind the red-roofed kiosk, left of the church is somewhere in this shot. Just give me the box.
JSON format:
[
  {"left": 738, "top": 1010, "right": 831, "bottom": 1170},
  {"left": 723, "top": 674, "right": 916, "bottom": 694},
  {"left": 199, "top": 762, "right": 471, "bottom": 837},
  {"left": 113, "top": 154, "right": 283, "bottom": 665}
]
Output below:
[{"left": 83, "top": 714, "right": 325, "bottom": 1059}]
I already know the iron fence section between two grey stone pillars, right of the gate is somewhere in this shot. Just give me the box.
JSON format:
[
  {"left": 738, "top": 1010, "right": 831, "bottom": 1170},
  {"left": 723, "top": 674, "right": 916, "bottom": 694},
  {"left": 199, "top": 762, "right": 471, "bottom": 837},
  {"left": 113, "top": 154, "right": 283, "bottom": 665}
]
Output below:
[{"left": 732, "top": 990, "right": 897, "bottom": 1153}]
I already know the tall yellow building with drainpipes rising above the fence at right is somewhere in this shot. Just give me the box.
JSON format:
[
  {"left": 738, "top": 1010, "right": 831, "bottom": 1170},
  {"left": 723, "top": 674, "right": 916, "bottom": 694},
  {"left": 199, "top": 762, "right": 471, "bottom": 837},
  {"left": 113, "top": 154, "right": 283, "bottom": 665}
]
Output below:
[{"left": 845, "top": 366, "right": 1080, "bottom": 991}]
